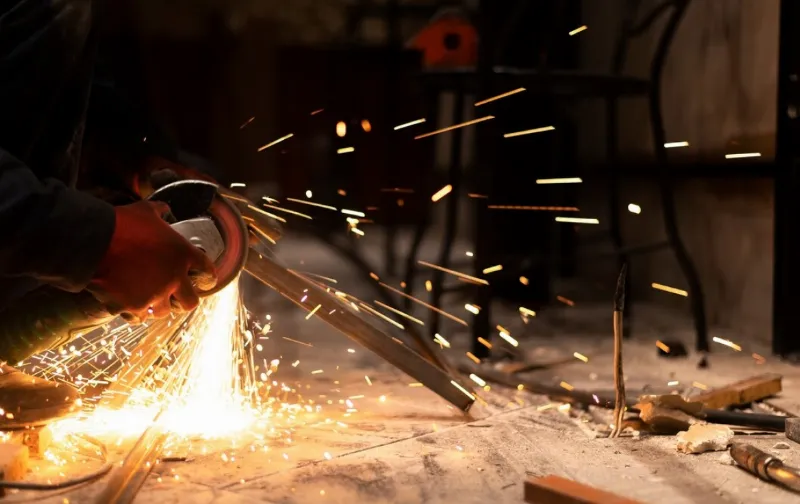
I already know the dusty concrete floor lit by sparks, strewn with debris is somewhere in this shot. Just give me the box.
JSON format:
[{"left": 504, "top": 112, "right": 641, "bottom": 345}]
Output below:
[{"left": 7, "top": 234, "right": 800, "bottom": 504}]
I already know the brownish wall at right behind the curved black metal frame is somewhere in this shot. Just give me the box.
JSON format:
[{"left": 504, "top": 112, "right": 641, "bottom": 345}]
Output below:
[{"left": 580, "top": 0, "right": 779, "bottom": 340}]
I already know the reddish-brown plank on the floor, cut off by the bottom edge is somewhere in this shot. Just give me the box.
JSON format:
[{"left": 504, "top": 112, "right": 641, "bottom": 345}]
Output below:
[{"left": 525, "top": 474, "right": 641, "bottom": 504}]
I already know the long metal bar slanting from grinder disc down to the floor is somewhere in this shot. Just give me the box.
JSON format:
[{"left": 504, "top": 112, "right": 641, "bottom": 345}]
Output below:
[{"left": 245, "top": 254, "right": 475, "bottom": 412}]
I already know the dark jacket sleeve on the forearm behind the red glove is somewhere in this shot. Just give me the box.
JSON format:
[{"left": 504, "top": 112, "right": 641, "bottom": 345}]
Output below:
[{"left": 0, "top": 149, "right": 115, "bottom": 292}]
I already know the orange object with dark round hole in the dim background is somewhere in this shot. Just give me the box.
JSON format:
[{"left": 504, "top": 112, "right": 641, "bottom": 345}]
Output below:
[{"left": 409, "top": 14, "right": 478, "bottom": 68}]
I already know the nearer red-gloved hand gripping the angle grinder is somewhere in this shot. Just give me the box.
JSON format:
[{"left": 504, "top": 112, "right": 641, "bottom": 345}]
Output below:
[{"left": 89, "top": 201, "right": 215, "bottom": 321}]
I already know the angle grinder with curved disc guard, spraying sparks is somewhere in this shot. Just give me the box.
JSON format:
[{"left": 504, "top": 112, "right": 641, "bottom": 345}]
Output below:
[{"left": 0, "top": 180, "right": 280, "bottom": 363}]
